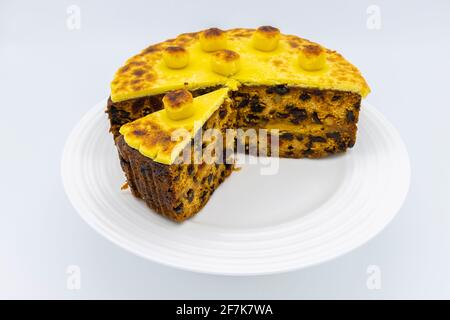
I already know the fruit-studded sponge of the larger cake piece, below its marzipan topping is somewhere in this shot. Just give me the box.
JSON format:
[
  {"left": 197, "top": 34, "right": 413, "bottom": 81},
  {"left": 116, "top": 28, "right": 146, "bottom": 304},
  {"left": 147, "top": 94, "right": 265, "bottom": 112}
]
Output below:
[{"left": 107, "top": 85, "right": 361, "bottom": 158}]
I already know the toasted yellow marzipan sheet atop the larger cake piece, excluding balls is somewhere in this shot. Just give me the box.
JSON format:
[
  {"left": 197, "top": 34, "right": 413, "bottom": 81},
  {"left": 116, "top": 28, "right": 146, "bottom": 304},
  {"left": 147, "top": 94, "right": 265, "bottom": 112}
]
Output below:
[{"left": 111, "top": 29, "right": 370, "bottom": 102}]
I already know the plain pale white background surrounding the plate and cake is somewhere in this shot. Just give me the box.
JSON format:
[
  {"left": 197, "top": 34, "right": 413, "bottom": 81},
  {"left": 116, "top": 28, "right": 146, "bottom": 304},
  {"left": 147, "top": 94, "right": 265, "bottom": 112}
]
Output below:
[{"left": 0, "top": 0, "right": 450, "bottom": 299}]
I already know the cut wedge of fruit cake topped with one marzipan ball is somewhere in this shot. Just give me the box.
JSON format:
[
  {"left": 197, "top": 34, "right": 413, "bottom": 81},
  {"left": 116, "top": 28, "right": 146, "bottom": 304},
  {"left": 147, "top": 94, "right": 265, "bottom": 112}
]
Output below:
[{"left": 116, "top": 88, "right": 236, "bottom": 221}]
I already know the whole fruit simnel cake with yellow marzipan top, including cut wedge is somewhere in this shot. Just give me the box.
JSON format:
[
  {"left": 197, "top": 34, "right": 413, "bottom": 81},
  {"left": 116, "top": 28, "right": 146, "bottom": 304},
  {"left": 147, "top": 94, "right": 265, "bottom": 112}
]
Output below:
[{"left": 107, "top": 26, "right": 370, "bottom": 221}]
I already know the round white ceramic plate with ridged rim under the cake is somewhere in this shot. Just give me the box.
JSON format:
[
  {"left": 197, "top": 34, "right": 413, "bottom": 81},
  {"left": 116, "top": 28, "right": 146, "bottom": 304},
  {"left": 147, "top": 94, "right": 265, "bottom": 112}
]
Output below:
[{"left": 61, "top": 101, "right": 410, "bottom": 275}]
